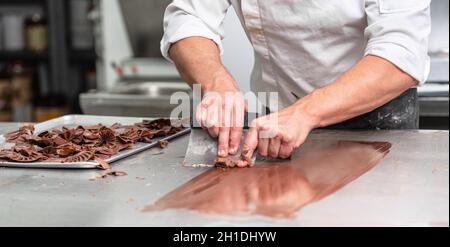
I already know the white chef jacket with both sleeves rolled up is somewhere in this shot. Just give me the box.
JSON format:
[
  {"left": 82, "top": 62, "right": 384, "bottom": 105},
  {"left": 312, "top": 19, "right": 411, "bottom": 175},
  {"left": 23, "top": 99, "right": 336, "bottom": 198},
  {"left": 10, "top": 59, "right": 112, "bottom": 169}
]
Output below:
[{"left": 161, "top": 0, "right": 431, "bottom": 108}]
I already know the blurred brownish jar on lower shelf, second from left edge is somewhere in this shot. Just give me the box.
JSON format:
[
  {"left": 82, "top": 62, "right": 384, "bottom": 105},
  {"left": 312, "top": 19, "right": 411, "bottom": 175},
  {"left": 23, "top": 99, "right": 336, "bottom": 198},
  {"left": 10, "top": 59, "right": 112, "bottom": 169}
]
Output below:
[{"left": 9, "top": 62, "right": 33, "bottom": 122}]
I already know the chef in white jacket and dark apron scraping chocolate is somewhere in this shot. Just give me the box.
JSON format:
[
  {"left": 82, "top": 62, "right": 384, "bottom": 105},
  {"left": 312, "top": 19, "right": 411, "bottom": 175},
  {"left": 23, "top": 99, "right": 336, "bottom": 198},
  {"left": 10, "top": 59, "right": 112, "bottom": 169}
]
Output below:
[{"left": 161, "top": 0, "right": 431, "bottom": 165}]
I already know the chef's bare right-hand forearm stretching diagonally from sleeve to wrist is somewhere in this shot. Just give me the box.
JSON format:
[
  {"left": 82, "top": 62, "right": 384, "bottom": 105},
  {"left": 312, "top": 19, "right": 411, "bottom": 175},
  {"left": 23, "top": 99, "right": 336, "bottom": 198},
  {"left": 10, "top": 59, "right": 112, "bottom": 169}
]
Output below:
[{"left": 296, "top": 56, "right": 417, "bottom": 128}]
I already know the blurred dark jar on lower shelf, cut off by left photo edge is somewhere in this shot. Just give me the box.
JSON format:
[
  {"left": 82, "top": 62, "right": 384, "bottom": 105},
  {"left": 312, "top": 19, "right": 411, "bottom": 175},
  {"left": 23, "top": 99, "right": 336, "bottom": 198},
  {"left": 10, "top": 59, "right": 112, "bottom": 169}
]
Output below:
[{"left": 0, "top": 71, "right": 12, "bottom": 122}]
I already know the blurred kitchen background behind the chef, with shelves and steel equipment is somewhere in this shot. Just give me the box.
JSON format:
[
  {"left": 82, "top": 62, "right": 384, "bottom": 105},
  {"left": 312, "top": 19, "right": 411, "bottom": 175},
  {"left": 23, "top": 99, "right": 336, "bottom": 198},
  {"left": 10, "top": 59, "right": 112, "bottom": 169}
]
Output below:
[{"left": 0, "top": 0, "right": 449, "bottom": 129}]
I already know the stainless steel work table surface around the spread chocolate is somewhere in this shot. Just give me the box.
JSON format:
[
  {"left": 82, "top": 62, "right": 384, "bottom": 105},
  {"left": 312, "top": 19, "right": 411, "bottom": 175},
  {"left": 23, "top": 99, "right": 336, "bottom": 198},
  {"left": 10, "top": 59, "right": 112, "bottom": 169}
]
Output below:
[{"left": 0, "top": 124, "right": 449, "bottom": 226}]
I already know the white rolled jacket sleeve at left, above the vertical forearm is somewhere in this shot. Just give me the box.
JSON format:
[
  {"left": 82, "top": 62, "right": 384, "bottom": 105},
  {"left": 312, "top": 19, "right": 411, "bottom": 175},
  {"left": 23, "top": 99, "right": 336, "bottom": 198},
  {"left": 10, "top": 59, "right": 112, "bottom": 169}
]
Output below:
[{"left": 161, "top": 0, "right": 231, "bottom": 61}]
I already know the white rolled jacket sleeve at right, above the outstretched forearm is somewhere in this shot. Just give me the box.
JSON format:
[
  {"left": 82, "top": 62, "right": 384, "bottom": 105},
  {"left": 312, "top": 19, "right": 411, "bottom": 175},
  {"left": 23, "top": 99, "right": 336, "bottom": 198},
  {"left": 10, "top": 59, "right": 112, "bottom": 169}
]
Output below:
[{"left": 365, "top": 0, "right": 431, "bottom": 83}]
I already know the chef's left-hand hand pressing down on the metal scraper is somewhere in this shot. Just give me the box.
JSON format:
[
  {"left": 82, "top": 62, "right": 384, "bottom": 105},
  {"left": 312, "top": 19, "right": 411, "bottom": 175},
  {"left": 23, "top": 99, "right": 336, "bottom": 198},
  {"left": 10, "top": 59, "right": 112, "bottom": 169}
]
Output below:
[{"left": 196, "top": 80, "right": 247, "bottom": 157}]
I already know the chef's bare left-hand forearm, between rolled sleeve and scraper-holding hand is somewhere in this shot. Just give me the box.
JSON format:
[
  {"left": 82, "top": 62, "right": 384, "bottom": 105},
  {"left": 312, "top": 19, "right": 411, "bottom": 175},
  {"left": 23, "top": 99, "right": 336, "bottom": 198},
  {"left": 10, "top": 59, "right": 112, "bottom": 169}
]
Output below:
[{"left": 169, "top": 37, "right": 237, "bottom": 92}]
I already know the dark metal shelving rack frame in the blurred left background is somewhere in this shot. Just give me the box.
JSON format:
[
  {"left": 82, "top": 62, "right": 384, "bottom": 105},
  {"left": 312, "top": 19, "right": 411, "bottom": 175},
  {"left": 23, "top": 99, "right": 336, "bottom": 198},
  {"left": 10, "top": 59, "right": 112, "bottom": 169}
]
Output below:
[{"left": 0, "top": 0, "right": 97, "bottom": 113}]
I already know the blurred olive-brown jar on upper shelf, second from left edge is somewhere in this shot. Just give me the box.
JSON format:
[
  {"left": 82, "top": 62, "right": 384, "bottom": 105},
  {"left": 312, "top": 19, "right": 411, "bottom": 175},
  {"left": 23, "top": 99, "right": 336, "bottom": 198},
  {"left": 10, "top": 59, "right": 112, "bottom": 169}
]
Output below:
[{"left": 25, "top": 14, "right": 48, "bottom": 53}]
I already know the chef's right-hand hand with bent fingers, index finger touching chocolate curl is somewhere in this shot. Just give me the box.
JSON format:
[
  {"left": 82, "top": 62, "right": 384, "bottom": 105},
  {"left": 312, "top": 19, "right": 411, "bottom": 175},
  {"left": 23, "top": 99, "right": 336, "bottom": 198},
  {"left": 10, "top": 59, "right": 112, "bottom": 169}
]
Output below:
[{"left": 240, "top": 105, "right": 316, "bottom": 162}]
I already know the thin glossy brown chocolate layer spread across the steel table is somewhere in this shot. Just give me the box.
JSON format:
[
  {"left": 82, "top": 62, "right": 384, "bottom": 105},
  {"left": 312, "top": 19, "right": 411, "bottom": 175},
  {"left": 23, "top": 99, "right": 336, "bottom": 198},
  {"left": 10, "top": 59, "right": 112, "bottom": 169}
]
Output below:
[{"left": 144, "top": 140, "right": 391, "bottom": 218}]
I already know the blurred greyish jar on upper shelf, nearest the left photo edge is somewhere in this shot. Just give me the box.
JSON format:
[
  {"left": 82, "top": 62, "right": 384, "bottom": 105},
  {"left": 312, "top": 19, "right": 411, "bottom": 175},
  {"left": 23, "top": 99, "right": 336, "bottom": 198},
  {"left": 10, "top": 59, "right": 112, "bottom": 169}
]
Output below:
[{"left": 2, "top": 14, "right": 25, "bottom": 51}]
